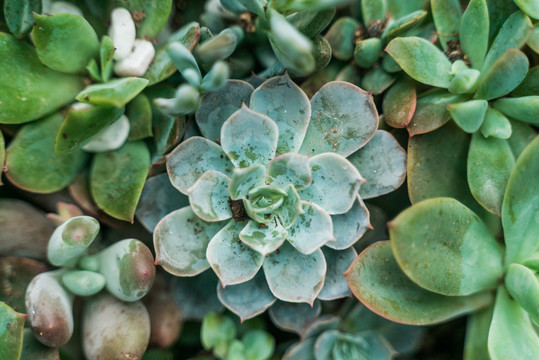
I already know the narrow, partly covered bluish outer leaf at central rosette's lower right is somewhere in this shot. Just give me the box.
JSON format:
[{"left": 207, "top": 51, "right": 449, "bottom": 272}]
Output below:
[{"left": 318, "top": 247, "right": 357, "bottom": 300}]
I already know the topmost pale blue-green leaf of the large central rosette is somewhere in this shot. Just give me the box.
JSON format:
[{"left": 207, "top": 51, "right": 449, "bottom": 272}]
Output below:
[{"left": 250, "top": 74, "right": 311, "bottom": 154}]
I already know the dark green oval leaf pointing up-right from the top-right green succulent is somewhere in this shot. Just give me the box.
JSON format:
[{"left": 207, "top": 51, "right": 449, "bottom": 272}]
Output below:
[{"left": 475, "top": 49, "right": 529, "bottom": 100}]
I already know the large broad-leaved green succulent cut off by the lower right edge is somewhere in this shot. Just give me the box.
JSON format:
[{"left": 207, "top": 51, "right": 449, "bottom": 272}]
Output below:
[{"left": 346, "top": 137, "right": 539, "bottom": 359}]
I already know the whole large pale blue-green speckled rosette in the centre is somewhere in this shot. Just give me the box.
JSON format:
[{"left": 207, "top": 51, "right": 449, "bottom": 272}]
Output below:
[{"left": 154, "top": 75, "right": 406, "bottom": 318}]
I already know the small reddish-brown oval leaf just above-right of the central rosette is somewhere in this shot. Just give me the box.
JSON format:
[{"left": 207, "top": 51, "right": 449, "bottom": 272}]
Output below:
[{"left": 382, "top": 79, "right": 417, "bottom": 128}]
